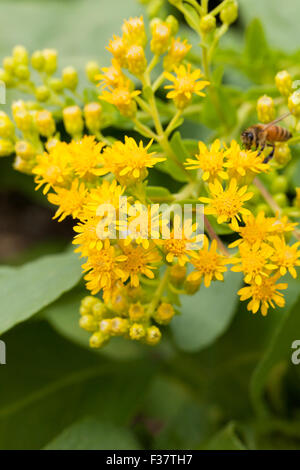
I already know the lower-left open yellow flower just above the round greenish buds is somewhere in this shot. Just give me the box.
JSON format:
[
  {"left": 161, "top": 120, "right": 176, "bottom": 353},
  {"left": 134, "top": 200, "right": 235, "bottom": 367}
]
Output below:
[{"left": 82, "top": 240, "right": 126, "bottom": 301}]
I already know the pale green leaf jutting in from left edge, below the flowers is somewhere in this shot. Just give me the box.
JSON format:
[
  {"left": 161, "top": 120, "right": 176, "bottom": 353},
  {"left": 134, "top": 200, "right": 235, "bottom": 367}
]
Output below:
[{"left": 0, "top": 252, "right": 81, "bottom": 334}]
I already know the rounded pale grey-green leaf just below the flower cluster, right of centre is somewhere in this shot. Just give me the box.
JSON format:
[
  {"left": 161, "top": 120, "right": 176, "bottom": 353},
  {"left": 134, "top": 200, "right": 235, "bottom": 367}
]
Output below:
[{"left": 171, "top": 272, "right": 241, "bottom": 351}]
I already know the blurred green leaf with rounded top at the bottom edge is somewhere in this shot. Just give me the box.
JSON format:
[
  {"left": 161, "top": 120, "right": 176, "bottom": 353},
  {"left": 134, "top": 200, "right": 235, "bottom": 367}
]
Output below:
[{"left": 45, "top": 418, "right": 140, "bottom": 450}]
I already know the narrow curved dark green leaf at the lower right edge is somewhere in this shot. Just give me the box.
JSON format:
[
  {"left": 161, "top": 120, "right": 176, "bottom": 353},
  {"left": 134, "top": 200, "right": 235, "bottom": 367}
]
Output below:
[{"left": 250, "top": 281, "right": 300, "bottom": 415}]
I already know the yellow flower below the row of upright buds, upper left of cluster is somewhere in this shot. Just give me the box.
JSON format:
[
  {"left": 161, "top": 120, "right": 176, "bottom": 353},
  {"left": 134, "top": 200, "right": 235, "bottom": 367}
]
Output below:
[{"left": 69, "top": 135, "right": 103, "bottom": 180}]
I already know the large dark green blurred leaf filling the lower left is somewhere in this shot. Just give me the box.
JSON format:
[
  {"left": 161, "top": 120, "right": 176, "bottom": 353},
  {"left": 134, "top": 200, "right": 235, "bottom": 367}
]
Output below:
[{"left": 0, "top": 322, "right": 155, "bottom": 449}]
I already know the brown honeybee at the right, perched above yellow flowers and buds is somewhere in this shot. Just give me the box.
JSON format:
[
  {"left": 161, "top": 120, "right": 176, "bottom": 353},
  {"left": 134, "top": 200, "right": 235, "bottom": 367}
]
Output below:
[{"left": 241, "top": 113, "right": 292, "bottom": 163}]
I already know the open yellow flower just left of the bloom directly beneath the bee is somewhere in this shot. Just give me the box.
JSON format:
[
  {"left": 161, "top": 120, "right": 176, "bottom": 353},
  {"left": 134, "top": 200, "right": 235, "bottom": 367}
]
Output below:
[{"left": 185, "top": 139, "right": 228, "bottom": 181}]
